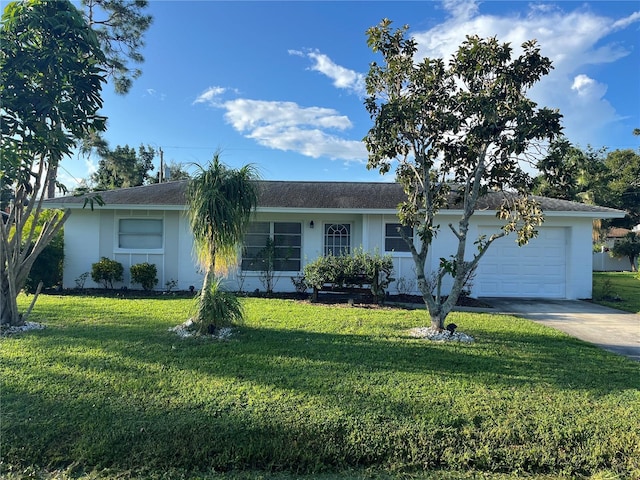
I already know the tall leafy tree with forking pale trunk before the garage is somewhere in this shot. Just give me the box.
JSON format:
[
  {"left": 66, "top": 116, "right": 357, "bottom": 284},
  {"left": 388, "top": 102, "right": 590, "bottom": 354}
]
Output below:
[{"left": 364, "top": 19, "right": 561, "bottom": 330}]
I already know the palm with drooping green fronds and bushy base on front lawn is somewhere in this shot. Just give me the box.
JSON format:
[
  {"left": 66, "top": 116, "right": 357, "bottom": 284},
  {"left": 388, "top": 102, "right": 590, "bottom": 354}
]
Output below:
[{"left": 186, "top": 153, "right": 258, "bottom": 331}]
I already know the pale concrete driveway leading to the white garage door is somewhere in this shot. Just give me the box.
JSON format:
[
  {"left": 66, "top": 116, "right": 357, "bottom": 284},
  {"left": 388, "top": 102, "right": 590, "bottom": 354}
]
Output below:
[{"left": 482, "top": 298, "right": 640, "bottom": 362}]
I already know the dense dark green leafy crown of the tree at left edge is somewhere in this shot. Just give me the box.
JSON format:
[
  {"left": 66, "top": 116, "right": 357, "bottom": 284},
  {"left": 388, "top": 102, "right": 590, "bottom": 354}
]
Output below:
[{"left": 0, "top": 0, "right": 105, "bottom": 165}]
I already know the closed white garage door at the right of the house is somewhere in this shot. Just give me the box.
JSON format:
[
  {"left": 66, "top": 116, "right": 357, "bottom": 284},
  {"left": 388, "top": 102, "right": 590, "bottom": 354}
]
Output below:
[{"left": 474, "top": 227, "right": 566, "bottom": 298}]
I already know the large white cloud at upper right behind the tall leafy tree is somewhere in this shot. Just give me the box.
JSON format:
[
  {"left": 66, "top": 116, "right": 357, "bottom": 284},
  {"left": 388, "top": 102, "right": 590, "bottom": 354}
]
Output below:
[{"left": 413, "top": 0, "right": 640, "bottom": 145}]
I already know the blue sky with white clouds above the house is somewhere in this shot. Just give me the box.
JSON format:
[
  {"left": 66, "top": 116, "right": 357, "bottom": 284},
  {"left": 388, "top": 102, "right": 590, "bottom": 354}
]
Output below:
[{"left": 61, "top": 0, "right": 640, "bottom": 187}]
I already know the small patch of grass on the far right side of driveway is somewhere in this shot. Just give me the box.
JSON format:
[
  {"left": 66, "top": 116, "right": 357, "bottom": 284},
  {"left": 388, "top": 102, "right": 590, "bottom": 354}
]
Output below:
[{"left": 593, "top": 272, "right": 640, "bottom": 314}]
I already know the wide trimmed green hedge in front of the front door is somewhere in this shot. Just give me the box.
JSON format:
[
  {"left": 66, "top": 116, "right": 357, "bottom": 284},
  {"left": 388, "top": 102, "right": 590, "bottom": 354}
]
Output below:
[{"left": 304, "top": 248, "right": 394, "bottom": 297}]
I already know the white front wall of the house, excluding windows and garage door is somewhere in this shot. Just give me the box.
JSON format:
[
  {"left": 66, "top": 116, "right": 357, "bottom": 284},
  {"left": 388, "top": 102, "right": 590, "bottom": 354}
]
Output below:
[{"left": 63, "top": 209, "right": 592, "bottom": 298}]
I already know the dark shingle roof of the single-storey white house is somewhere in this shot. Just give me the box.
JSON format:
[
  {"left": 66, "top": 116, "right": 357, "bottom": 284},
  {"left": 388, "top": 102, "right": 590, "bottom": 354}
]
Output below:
[{"left": 46, "top": 180, "right": 624, "bottom": 217}]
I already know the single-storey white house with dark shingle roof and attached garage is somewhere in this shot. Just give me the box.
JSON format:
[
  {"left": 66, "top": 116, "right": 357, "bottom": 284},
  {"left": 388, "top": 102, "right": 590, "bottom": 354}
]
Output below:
[{"left": 47, "top": 181, "right": 624, "bottom": 299}]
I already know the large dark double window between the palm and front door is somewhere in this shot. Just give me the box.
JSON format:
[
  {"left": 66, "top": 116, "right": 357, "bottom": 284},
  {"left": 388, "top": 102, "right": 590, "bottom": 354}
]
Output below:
[{"left": 241, "top": 222, "right": 302, "bottom": 272}]
